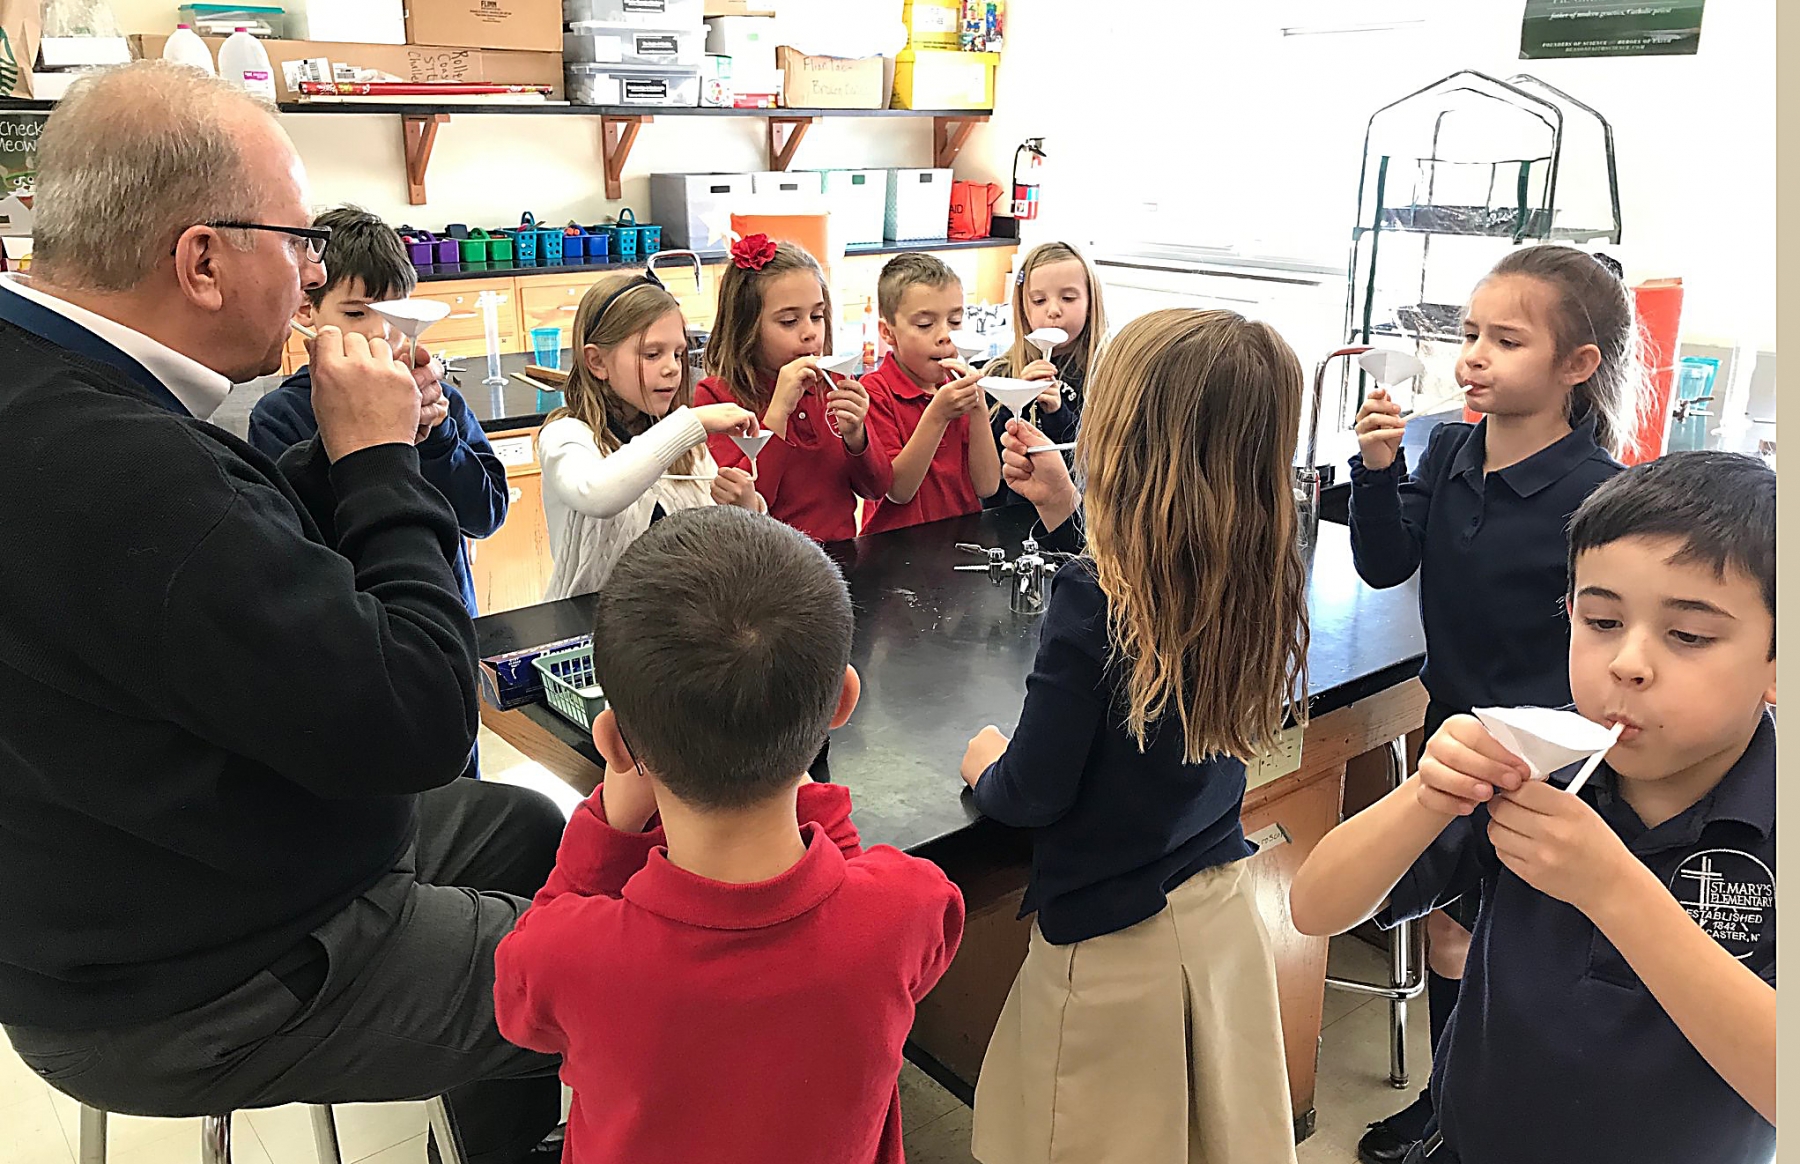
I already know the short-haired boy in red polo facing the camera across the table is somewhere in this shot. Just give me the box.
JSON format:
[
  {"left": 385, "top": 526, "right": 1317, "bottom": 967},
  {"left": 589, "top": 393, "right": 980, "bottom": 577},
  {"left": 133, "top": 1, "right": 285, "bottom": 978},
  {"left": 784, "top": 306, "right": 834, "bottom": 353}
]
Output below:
[{"left": 862, "top": 254, "right": 1001, "bottom": 534}]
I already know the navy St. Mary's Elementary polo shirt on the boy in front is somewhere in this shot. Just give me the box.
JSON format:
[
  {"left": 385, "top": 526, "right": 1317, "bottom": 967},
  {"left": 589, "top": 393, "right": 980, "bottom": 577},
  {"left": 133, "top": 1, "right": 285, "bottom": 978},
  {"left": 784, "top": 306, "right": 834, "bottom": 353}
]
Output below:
[{"left": 1379, "top": 716, "right": 1775, "bottom": 1164}]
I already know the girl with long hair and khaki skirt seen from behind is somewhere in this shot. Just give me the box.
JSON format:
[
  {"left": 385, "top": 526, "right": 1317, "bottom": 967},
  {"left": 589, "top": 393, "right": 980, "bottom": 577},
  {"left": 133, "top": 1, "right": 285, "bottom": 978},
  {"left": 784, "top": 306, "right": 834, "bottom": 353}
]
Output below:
[{"left": 963, "top": 309, "right": 1307, "bottom": 1164}]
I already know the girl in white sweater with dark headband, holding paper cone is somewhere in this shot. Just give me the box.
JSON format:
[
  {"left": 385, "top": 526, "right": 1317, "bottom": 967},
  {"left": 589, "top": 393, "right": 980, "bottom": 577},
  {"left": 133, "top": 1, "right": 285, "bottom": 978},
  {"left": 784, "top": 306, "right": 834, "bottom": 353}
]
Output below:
[{"left": 538, "top": 275, "right": 765, "bottom": 601}]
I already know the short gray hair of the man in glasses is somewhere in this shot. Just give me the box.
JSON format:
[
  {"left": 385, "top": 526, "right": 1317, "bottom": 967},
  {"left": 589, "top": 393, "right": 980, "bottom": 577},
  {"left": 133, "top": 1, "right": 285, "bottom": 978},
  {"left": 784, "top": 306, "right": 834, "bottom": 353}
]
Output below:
[{"left": 32, "top": 61, "right": 274, "bottom": 291}]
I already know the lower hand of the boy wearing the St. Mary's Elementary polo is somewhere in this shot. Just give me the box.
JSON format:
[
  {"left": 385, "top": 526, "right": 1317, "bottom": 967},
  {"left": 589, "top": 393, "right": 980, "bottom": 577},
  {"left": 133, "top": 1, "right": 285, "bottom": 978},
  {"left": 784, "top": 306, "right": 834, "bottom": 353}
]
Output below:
[{"left": 1487, "top": 781, "right": 1640, "bottom": 918}]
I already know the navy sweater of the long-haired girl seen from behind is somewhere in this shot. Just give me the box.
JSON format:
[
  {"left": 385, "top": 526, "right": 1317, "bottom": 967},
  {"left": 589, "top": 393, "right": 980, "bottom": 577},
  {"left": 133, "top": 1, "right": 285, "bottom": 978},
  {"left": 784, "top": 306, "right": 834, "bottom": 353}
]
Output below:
[{"left": 974, "top": 550, "right": 1255, "bottom": 945}]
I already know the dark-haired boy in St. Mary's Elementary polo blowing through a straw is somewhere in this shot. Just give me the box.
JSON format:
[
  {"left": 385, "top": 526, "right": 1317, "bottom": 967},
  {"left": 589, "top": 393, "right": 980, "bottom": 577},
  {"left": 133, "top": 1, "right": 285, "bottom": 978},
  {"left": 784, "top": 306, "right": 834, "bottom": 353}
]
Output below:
[{"left": 1292, "top": 452, "right": 1775, "bottom": 1164}]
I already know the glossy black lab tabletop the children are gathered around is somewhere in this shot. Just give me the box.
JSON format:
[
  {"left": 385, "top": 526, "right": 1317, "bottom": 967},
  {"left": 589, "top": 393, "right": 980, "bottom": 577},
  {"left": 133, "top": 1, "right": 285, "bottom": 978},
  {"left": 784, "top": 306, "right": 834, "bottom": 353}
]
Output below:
[{"left": 475, "top": 507, "right": 1426, "bottom": 849}]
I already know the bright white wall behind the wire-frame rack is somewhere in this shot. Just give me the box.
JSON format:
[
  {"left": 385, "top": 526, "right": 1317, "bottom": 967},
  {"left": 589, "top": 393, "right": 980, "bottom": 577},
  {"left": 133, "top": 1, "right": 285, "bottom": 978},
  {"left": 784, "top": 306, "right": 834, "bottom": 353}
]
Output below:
[{"left": 959, "top": 0, "right": 1775, "bottom": 347}]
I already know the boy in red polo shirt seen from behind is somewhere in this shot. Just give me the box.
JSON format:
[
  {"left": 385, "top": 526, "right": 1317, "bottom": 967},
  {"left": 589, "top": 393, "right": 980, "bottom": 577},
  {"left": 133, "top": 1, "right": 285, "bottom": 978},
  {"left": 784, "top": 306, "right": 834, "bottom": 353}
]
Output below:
[{"left": 493, "top": 506, "right": 963, "bottom": 1164}]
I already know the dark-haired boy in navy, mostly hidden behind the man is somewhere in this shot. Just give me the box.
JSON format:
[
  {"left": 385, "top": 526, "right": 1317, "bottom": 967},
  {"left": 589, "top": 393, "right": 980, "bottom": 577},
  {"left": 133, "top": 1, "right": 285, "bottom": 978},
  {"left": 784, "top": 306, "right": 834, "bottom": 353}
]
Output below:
[{"left": 248, "top": 207, "right": 508, "bottom": 617}]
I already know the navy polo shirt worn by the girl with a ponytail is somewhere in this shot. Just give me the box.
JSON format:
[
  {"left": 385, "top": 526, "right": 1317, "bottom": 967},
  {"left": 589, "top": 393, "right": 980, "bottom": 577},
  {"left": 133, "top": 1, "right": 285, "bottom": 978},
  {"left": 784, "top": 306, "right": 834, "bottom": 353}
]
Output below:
[{"left": 1350, "top": 419, "right": 1624, "bottom": 711}]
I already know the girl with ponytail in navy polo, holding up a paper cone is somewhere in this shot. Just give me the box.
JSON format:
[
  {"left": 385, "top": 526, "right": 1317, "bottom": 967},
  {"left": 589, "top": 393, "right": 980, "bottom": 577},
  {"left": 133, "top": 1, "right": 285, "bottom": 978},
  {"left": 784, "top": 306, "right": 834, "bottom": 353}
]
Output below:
[{"left": 1350, "top": 246, "right": 1638, "bottom": 1164}]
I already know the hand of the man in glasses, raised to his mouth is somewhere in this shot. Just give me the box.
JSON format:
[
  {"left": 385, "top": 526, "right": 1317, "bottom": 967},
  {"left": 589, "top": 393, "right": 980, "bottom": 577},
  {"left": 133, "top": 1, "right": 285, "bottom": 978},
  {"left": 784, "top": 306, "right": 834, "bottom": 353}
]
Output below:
[{"left": 306, "top": 327, "right": 419, "bottom": 461}]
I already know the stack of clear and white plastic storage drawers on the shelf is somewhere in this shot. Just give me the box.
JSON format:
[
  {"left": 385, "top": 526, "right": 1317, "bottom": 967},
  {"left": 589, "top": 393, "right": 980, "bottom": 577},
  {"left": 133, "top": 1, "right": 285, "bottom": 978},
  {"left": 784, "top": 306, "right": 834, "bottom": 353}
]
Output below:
[{"left": 563, "top": 0, "right": 706, "bottom": 108}]
